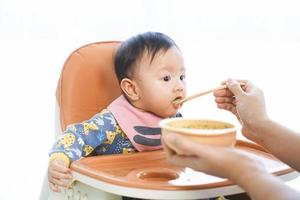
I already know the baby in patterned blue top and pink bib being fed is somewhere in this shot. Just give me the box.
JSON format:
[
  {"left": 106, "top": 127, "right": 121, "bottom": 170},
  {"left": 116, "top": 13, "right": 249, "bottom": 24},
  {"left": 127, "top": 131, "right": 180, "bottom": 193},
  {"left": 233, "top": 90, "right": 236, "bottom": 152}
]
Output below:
[{"left": 48, "top": 32, "right": 186, "bottom": 192}]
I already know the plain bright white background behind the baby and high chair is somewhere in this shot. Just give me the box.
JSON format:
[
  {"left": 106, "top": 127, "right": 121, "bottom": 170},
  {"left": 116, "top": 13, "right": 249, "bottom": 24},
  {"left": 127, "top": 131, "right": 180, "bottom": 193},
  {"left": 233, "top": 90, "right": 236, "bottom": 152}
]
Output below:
[{"left": 0, "top": 0, "right": 300, "bottom": 200}]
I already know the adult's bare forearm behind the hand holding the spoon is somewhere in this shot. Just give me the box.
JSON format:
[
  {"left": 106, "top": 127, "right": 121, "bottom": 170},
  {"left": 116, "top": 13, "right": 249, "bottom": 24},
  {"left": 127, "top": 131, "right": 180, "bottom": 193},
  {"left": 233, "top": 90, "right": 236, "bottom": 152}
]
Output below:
[{"left": 255, "top": 120, "right": 300, "bottom": 171}]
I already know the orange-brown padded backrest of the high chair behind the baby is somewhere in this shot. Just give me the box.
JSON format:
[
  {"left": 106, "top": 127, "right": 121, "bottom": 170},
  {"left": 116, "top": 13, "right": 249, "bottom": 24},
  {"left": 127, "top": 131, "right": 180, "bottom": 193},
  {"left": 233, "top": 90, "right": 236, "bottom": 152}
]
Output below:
[{"left": 56, "top": 42, "right": 121, "bottom": 130}]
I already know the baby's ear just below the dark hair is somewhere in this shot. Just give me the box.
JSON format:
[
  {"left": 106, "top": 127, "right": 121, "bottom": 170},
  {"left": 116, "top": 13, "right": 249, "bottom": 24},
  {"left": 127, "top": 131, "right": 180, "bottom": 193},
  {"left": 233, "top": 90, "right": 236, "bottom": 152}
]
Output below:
[{"left": 120, "top": 78, "right": 140, "bottom": 101}]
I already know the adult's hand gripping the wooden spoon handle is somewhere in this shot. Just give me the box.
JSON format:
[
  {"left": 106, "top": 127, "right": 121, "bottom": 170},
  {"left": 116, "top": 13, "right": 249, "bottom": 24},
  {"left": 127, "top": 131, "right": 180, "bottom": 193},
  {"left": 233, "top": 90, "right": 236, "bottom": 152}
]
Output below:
[{"left": 214, "top": 79, "right": 268, "bottom": 141}]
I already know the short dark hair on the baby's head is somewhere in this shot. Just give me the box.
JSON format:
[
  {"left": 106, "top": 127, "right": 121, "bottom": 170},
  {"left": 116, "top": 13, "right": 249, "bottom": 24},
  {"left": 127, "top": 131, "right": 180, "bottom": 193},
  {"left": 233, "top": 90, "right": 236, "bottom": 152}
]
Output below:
[{"left": 115, "top": 32, "right": 178, "bottom": 82}]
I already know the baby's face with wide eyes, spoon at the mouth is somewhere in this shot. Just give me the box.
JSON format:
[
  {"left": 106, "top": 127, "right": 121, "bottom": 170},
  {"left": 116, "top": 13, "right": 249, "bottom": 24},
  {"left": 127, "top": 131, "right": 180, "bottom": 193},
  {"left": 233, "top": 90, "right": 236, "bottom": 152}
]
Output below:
[{"left": 133, "top": 47, "right": 186, "bottom": 117}]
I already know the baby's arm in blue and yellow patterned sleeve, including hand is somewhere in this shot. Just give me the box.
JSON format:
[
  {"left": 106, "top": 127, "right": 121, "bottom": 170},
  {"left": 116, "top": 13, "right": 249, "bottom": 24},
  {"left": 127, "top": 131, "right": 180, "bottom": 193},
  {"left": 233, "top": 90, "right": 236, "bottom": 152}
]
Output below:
[{"left": 48, "top": 111, "right": 109, "bottom": 192}]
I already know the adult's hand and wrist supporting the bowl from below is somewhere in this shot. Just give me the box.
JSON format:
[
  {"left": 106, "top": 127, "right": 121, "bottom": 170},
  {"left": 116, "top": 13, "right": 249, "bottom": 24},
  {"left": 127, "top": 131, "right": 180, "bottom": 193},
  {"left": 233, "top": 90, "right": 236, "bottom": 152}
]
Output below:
[{"left": 163, "top": 134, "right": 265, "bottom": 183}]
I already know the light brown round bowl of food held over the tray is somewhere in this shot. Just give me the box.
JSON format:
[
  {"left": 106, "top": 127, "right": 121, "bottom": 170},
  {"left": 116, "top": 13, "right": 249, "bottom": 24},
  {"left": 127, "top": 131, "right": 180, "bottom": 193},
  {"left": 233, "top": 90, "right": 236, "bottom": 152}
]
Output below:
[{"left": 159, "top": 118, "right": 236, "bottom": 147}]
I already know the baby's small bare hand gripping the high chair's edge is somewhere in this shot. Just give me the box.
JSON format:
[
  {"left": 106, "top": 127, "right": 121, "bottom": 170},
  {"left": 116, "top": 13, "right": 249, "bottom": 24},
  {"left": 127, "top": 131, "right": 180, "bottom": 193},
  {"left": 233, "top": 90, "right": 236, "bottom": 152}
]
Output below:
[{"left": 48, "top": 159, "right": 72, "bottom": 192}]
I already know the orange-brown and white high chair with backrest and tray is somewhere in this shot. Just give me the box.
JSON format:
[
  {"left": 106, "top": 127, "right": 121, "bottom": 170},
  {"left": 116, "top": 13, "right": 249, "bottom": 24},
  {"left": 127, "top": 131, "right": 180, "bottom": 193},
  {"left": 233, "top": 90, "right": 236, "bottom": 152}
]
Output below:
[{"left": 44, "top": 42, "right": 297, "bottom": 200}]
